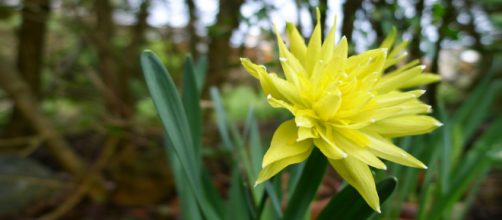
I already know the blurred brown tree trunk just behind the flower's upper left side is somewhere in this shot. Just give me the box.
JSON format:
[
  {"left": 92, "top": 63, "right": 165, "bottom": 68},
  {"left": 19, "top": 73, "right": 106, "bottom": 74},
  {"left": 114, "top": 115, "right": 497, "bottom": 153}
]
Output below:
[{"left": 204, "top": 0, "right": 244, "bottom": 97}]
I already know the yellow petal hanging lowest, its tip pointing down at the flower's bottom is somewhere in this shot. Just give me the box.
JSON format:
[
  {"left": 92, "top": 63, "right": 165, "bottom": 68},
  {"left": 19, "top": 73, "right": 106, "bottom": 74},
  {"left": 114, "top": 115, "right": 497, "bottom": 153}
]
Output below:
[{"left": 329, "top": 156, "right": 380, "bottom": 213}]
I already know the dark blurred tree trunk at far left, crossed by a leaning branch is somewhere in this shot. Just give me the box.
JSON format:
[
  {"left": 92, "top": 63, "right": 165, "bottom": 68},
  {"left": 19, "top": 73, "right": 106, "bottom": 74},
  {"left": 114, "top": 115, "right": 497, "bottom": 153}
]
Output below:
[{"left": 5, "top": 0, "right": 50, "bottom": 137}]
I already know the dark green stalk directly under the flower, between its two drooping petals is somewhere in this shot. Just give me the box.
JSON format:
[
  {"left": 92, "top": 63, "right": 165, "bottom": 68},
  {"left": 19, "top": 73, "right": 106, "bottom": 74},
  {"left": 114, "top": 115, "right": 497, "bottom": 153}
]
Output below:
[{"left": 284, "top": 148, "right": 328, "bottom": 220}]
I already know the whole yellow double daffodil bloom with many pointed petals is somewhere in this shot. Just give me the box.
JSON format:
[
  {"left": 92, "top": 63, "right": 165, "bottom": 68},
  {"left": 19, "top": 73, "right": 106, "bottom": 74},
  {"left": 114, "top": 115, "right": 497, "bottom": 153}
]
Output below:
[{"left": 241, "top": 9, "right": 441, "bottom": 212}]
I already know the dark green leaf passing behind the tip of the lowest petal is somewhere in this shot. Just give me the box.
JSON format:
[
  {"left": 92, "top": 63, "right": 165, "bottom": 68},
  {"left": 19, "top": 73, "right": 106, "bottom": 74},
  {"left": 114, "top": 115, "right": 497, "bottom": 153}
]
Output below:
[{"left": 317, "top": 177, "right": 397, "bottom": 220}]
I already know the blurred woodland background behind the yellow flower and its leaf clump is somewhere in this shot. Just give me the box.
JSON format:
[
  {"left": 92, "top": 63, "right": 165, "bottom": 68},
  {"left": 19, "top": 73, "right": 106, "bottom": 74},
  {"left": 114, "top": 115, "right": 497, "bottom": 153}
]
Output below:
[{"left": 0, "top": 0, "right": 502, "bottom": 219}]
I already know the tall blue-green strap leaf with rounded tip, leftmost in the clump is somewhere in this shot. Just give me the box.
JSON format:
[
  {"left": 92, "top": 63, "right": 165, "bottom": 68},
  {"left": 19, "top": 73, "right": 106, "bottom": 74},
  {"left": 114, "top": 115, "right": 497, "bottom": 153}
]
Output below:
[{"left": 141, "top": 51, "right": 220, "bottom": 219}]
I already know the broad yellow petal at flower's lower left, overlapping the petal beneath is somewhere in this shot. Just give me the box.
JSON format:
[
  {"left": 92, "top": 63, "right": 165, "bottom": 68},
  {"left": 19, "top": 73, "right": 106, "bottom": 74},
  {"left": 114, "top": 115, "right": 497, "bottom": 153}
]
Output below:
[{"left": 262, "top": 120, "right": 312, "bottom": 167}]
